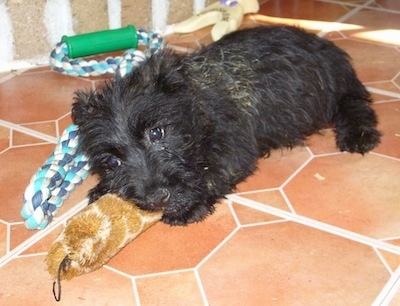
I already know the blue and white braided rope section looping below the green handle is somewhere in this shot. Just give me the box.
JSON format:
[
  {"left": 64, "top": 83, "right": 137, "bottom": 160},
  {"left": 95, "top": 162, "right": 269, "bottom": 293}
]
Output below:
[{"left": 50, "top": 30, "right": 163, "bottom": 77}]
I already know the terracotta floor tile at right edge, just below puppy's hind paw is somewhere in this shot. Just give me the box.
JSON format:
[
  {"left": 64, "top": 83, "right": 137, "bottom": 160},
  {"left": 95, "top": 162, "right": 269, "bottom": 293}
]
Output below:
[{"left": 284, "top": 153, "right": 400, "bottom": 238}]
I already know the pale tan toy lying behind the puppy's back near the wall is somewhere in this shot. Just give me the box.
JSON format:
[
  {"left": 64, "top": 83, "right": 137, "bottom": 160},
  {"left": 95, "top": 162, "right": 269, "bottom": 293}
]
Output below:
[{"left": 172, "top": 0, "right": 260, "bottom": 41}]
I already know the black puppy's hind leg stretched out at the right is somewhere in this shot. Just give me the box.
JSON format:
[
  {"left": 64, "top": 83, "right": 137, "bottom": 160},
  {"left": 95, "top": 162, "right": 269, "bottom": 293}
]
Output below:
[{"left": 335, "top": 82, "right": 381, "bottom": 154}]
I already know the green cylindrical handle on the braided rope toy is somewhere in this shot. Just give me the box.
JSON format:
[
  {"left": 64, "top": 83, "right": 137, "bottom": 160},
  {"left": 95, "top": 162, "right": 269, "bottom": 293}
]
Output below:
[{"left": 61, "top": 25, "right": 138, "bottom": 58}]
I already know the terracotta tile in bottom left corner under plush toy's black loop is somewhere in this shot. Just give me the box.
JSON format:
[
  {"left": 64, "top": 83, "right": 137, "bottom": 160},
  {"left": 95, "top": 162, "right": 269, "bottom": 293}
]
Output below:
[{"left": 0, "top": 256, "right": 135, "bottom": 306}]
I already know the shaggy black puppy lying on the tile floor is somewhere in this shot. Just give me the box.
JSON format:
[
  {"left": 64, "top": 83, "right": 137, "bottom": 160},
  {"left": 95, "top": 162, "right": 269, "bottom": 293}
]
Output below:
[{"left": 72, "top": 26, "right": 380, "bottom": 225}]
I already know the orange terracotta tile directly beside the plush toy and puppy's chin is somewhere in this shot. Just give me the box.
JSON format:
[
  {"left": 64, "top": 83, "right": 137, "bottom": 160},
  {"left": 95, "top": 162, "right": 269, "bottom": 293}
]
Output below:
[{"left": 108, "top": 204, "right": 237, "bottom": 275}]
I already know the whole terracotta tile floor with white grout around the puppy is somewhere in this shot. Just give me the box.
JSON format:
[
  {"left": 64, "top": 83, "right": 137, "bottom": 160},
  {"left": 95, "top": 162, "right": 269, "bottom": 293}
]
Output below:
[{"left": 0, "top": 0, "right": 400, "bottom": 306}]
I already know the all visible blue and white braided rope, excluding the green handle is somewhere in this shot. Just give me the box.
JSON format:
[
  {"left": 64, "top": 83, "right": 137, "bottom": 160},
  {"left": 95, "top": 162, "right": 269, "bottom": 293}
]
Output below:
[{"left": 21, "top": 30, "right": 162, "bottom": 230}]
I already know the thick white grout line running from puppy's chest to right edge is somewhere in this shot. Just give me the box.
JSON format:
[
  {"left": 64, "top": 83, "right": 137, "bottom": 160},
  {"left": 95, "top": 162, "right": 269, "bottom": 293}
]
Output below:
[{"left": 228, "top": 195, "right": 400, "bottom": 255}]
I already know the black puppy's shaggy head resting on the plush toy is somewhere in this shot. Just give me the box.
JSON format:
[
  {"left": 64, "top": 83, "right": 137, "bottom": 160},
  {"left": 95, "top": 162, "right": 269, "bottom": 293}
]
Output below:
[{"left": 72, "top": 52, "right": 217, "bottom": 224}]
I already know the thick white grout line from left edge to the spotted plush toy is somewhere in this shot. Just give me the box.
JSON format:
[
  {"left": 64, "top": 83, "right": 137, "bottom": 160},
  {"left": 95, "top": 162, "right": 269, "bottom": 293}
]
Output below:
[{"left": 0, "top": 199, "right": 88, "bottom": 268}]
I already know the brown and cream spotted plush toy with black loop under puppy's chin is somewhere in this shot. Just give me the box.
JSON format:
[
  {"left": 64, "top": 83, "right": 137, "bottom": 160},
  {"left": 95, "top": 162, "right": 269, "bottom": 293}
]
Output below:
[{"left": 45, "top": 194, "right": 162, "bottom": 301}]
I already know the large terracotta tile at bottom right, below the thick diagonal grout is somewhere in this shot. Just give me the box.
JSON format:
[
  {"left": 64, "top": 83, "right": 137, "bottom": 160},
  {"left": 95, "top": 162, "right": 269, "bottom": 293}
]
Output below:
[{"left": 199, "top": 222, "right": 390, "bottom": 305}]
